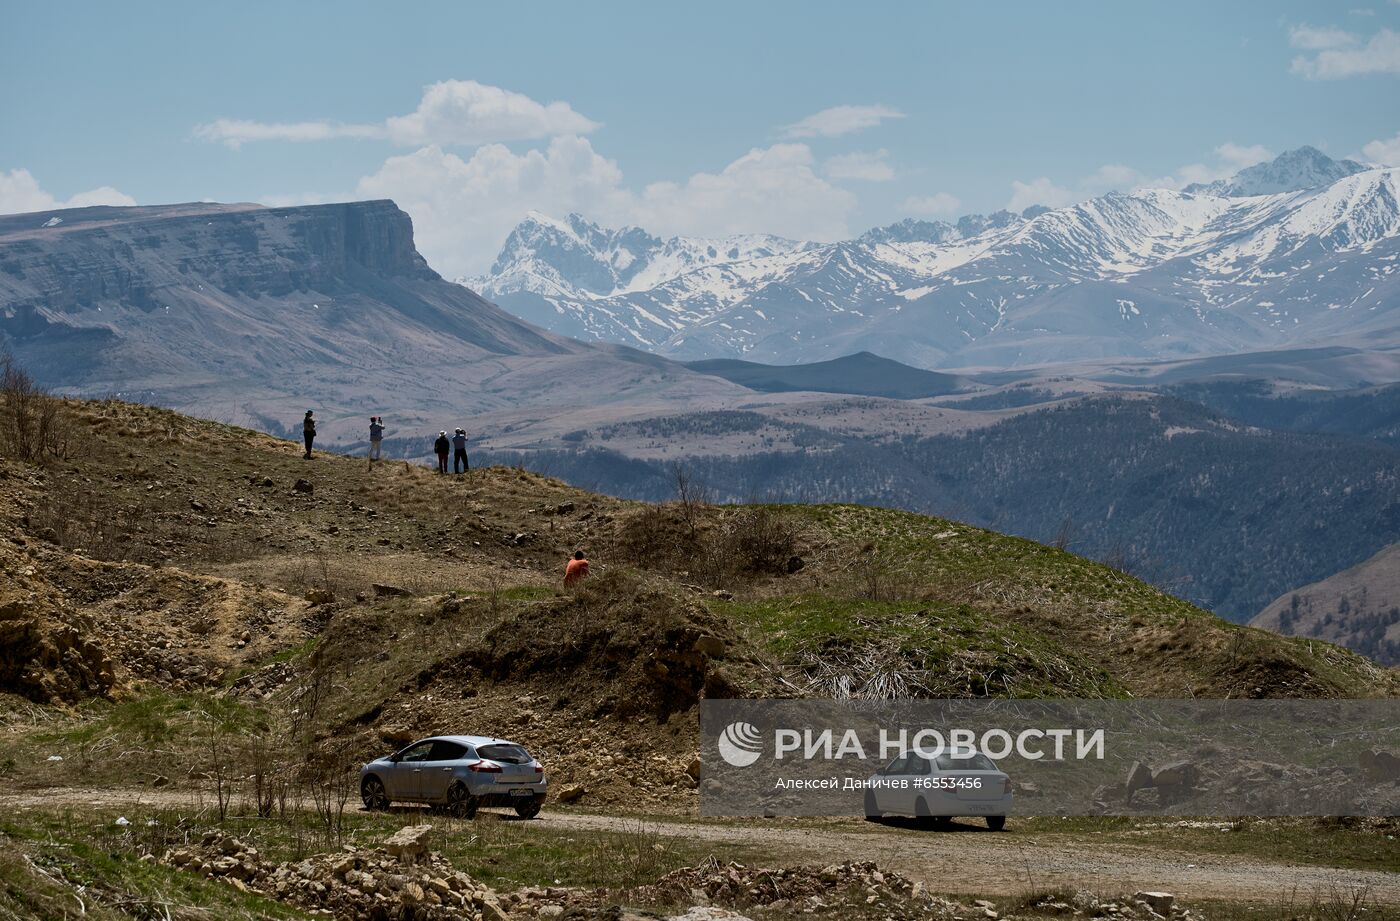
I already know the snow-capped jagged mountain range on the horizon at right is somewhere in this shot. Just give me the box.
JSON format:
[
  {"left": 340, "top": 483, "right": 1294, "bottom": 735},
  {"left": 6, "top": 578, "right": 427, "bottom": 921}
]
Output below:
[{"left": 463, "top": 148, "right": 1400, "bottom": 368}]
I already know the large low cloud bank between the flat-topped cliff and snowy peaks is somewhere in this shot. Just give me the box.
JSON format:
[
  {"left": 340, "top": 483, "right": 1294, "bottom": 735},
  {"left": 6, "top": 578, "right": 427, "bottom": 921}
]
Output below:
[{"left": 356, "top": 136, "right": 855, "bottom": 277}]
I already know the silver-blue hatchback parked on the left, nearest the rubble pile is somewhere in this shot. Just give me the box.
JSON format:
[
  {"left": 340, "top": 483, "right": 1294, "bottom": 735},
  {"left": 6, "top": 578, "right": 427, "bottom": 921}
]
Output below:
[{"left": 360, "top": 735, "right": 549, "bottom": 819}]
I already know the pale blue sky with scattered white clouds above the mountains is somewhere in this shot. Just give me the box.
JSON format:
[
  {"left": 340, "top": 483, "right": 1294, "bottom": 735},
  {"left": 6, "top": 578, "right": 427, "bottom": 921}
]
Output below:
[{"left": 8, "top": 0, "right": 1400, "bottom": 277}]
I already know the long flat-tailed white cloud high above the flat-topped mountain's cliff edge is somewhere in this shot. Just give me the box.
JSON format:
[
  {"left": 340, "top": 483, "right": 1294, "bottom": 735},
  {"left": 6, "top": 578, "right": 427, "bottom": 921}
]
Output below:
[{"left": 195, "top": 80, "right": 598, "bottom": 150}]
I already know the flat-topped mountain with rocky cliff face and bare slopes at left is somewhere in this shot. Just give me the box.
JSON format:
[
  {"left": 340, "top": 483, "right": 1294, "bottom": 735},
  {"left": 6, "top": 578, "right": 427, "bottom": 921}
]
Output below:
[{"left": 0, "top": 202, "right": 744, "bottom": 440}]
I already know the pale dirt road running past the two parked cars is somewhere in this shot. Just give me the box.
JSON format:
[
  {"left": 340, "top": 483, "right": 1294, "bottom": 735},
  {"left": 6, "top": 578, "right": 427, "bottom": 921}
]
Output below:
[{"left": 0, "top": 789, "right": 1400, "bottom": 906}]
